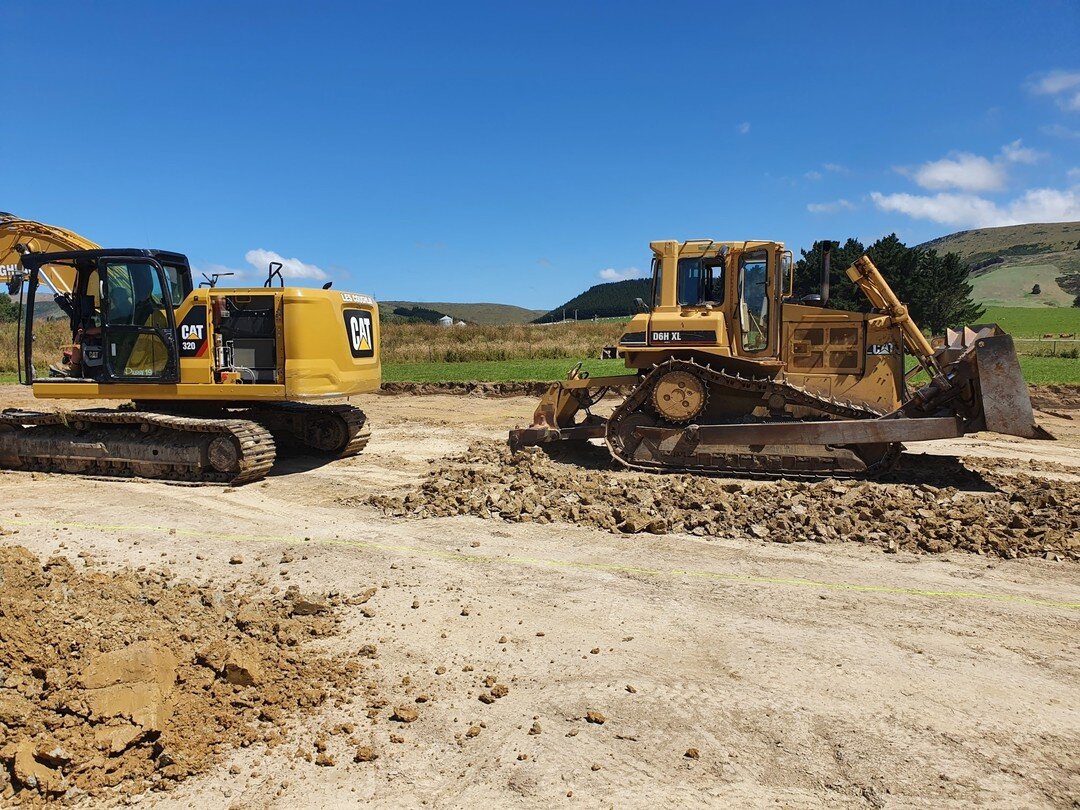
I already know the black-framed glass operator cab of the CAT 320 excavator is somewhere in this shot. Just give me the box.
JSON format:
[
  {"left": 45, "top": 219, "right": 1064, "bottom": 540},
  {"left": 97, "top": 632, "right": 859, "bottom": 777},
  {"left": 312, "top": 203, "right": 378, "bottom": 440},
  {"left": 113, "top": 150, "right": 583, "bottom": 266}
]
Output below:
[{"left": 22, "top": 249, "right": 192, "bottom": 383}]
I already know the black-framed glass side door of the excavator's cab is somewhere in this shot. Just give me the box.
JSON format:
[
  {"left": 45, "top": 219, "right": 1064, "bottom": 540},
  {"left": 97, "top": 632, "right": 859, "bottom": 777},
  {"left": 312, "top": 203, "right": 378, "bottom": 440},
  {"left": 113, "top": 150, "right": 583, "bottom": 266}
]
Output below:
[{"left": 97, "top": 256, "right": 179, "bottom": 382}]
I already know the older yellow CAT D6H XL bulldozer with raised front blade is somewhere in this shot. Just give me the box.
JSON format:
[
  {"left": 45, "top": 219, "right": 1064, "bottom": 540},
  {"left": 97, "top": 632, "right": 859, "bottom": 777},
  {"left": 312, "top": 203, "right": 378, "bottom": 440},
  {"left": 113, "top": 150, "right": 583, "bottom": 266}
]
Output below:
[{"left": 510, "top": 240, "right": 1052, "bottom": 476}]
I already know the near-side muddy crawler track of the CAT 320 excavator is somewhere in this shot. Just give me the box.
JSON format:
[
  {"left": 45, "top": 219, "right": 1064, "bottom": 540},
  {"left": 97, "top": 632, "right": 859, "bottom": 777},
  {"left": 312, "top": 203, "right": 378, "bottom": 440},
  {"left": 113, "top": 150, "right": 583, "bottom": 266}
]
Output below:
[{"left": 0, "top": 409, "right": 276, "bottom": 485}]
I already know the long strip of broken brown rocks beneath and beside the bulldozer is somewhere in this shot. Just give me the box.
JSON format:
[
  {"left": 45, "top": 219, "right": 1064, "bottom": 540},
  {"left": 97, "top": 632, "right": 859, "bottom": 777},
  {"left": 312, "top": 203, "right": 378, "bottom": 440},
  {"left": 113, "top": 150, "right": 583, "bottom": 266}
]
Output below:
[{"left": 366, "top": 442, "right": 1080, "bottom": 561}]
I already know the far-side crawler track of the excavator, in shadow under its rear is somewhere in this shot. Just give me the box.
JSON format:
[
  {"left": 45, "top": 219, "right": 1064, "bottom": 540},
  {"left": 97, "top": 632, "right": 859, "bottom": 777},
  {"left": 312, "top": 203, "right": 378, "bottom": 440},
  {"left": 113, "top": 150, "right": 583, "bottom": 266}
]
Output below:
[{"left": 244, "top": 402, "right": 372, "bottom": 459}]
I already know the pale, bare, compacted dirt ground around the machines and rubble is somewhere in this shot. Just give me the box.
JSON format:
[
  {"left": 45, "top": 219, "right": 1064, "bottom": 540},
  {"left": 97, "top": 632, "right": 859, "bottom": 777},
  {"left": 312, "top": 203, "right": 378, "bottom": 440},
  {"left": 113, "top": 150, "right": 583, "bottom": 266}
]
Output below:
[{"left": 0, "top": 387, "right": 1080, "bottom": 808}]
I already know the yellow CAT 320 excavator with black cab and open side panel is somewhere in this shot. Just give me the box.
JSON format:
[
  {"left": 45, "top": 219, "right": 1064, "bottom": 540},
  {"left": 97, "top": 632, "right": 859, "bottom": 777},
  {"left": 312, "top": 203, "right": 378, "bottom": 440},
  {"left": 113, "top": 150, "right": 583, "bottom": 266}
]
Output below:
[{"left": 0, "top": 214, "right": 381, "bottom": 485}]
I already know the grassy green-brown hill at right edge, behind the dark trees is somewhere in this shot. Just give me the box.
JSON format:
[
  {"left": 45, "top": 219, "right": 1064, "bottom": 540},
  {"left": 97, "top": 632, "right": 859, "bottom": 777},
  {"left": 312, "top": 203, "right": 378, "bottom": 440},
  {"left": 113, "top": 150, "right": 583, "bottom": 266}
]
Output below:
[{"left": 920, "top": 222, "right": 1080, "bottom": 307}]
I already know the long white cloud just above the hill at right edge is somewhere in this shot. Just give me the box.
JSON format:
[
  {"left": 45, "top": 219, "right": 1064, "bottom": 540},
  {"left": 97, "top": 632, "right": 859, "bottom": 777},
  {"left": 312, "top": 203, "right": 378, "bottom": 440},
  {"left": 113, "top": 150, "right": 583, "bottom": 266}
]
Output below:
[{"left": 870, "top": 188, "right": 1080, "bottom": 228}]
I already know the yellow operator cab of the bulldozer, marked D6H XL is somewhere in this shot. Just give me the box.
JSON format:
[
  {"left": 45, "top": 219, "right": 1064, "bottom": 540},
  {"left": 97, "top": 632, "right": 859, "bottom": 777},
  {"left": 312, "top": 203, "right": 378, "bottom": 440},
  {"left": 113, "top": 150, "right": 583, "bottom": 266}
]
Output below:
[{"left": 635, "top": 240, "right": 792, "bottom": 361}]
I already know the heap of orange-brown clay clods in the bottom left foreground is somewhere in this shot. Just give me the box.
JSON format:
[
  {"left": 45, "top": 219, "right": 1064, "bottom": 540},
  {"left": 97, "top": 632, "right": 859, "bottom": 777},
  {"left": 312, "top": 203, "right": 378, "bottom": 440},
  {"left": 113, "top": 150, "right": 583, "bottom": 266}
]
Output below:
[{"left": 0, "top": 548, "right": 355, "bottom": 804}]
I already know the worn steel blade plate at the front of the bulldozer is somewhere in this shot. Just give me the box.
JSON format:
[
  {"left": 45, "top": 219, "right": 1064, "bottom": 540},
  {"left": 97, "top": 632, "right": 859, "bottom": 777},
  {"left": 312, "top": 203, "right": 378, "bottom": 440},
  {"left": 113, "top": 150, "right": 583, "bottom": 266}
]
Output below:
[{"left": 975, "top": 335, "right": 1054, "bottom": 440}]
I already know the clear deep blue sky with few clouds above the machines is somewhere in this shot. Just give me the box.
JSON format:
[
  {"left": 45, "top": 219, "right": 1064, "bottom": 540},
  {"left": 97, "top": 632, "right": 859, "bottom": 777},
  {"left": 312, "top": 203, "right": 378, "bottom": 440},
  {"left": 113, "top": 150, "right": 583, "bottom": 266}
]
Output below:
[{"left": 8, "top": 0, "right": 1080, "bottom": 309}]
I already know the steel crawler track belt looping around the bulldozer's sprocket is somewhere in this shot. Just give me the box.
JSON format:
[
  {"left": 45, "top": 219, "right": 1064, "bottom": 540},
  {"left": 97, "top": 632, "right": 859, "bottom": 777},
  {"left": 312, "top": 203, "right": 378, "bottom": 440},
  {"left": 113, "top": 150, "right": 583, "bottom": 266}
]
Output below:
[{"left": 605, "top": 360, "right": 903, "bottom": 478}]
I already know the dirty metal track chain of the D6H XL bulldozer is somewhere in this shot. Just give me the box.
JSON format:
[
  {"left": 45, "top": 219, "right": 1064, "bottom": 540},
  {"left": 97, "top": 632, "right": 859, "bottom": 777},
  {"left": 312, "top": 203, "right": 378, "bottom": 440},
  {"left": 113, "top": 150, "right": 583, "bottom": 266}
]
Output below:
[{"left": 606, "top": 359, "right": 902, "bottom": 478}]
